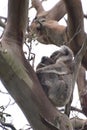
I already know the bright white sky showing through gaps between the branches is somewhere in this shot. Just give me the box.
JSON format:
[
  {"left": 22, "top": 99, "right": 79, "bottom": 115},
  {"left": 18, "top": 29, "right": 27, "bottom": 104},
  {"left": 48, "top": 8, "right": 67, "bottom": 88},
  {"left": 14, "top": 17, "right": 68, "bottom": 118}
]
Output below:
[{"left": 0, "top": 0, "right": 87, "bottom": 129}]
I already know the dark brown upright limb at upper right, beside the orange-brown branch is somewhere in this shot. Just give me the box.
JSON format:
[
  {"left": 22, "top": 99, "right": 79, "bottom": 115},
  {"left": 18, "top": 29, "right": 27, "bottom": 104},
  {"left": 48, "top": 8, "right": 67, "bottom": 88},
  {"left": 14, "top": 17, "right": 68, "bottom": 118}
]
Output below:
[{"left": 64, "top": 0, "right": 87, "bottom": 69}]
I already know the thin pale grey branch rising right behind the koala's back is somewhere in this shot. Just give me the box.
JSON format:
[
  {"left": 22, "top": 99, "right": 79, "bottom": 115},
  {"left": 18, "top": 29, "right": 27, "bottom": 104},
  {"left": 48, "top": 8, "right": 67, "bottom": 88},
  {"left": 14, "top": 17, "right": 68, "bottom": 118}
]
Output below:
[{"left": 65, "top": 38, "right": 87, "bottom": 116}]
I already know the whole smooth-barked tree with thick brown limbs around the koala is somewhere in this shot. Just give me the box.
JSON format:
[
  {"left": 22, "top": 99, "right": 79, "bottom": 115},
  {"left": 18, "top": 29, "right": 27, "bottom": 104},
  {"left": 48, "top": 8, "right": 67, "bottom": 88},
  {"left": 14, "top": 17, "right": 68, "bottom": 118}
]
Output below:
[{"left": 0, "top": 0, "right": 87, "bottom": 130}]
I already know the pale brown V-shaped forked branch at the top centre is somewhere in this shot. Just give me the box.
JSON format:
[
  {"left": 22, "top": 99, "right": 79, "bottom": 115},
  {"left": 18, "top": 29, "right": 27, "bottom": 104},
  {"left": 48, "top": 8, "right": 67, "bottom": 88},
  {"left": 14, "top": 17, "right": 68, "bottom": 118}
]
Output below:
[{"left": 32, "top": 0, "right": 66, "bottom": 21}]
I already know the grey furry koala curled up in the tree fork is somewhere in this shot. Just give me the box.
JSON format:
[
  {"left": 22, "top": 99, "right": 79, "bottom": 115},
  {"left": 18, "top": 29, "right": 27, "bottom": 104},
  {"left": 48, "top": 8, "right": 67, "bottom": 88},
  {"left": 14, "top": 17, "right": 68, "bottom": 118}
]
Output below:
[{"left": 36, "top": 45, "right": 73, "bottom": 107}]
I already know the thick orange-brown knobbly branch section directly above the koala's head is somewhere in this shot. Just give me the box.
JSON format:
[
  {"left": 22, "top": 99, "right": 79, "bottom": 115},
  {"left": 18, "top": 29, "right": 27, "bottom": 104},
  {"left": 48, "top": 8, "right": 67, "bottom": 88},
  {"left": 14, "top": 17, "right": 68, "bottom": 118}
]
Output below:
[{"left": 31, "top": 19, "right": 67, "bottom": 46}]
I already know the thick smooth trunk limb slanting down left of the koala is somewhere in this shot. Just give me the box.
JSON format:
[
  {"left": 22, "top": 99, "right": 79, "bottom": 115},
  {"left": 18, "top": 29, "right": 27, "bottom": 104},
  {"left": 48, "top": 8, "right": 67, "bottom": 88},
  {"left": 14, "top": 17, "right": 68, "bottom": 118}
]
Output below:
[{"left": 0, "top": 0, "right": 72, "bottom": 130}]
